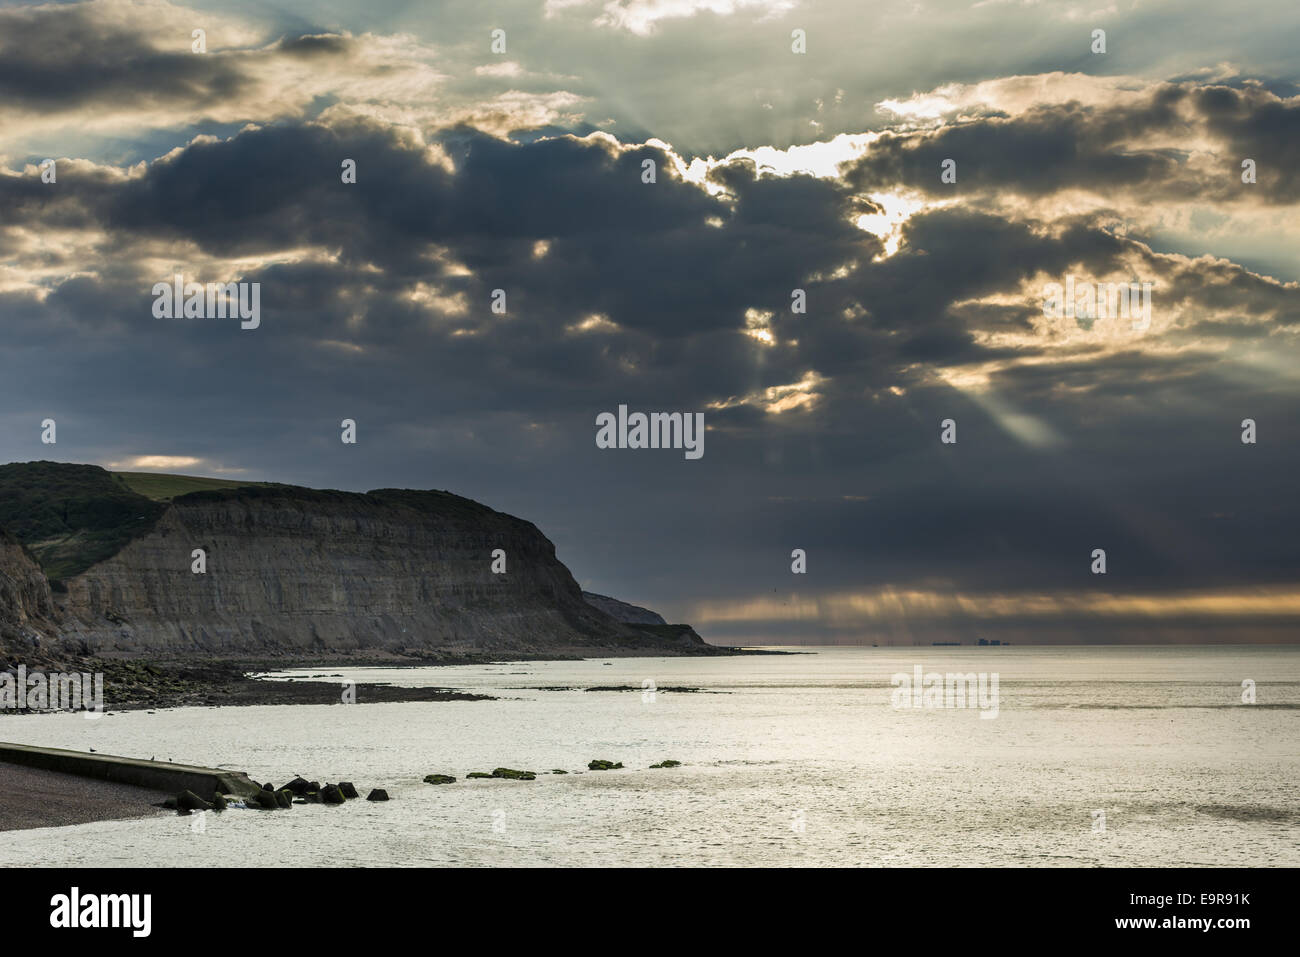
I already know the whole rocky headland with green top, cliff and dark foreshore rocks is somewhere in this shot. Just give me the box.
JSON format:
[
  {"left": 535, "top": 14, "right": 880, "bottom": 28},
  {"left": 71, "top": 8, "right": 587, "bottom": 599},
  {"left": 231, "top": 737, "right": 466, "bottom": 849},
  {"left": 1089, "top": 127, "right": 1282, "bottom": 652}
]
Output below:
[{"left": 0, "top": 462, "right": 733, "bottom": 707}]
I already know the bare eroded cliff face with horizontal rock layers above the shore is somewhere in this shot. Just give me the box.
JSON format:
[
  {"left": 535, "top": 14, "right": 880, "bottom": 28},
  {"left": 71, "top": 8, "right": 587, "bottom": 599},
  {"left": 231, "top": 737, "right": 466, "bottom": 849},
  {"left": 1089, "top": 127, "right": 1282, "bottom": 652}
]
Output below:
[{"left": 55, "top": 486, "right": 707, "bottom": 658}]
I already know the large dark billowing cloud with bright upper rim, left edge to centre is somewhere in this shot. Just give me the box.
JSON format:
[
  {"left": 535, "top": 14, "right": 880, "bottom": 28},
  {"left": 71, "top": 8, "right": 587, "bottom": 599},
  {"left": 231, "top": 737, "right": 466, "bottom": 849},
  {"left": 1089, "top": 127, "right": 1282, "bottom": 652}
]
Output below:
[{"left": 12, "top": 124, "right": 879, "bottom": 348}]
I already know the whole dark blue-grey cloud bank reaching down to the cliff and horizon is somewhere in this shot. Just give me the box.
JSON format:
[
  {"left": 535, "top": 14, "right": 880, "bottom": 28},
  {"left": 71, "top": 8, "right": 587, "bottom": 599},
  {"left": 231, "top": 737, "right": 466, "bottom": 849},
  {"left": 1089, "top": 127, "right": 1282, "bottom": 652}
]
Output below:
[{"left": 0, "top": 42, "right": 1300, "bottom": 642}]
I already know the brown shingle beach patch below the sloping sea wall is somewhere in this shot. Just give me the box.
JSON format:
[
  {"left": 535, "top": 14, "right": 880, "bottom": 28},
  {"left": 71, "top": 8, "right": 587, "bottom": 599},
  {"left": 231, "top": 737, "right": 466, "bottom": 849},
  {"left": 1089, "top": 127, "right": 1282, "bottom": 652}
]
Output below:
[{"left": 0, "top": 762, "right": 176, "bottom": 831}]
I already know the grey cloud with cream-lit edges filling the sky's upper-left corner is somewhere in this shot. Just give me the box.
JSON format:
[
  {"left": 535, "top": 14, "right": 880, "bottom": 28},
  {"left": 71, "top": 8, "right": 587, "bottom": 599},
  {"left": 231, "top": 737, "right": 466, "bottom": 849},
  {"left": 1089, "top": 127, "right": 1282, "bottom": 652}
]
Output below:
[{"left": 0, "top": 0, "right": 445, "bottom": 156}]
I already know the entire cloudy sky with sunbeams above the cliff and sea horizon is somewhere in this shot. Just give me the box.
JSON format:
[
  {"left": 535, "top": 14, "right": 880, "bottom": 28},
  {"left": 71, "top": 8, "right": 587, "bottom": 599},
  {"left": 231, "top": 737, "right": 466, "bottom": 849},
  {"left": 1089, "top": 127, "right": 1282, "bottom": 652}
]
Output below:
[{"left": 0, "top": 0, "right": 1300, "bottom": 644}]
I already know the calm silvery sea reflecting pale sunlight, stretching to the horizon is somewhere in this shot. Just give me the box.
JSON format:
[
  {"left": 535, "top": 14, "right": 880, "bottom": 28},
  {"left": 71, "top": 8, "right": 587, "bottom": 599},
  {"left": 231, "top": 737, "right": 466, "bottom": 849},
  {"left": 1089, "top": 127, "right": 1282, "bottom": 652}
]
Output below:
[{"left": 0, "top": 648, "right": 1300, "bottom": 866}]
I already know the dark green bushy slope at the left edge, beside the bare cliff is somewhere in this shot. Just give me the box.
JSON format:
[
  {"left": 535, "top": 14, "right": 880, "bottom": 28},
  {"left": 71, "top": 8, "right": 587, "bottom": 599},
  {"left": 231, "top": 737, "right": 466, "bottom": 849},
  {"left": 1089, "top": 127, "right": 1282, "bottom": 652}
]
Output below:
[{"left": 0, "top": 462, "right": 166, "bottom": 580}]
